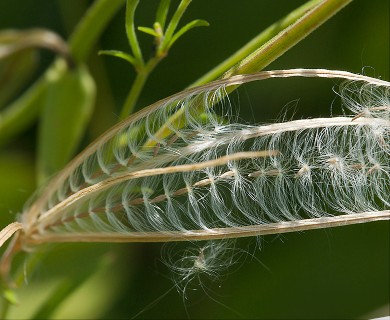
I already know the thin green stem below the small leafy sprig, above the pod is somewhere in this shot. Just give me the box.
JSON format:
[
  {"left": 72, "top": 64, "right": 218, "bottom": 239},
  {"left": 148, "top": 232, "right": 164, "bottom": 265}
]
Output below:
[{"left": 120, "top": 57, "right": 163, "bottom": 120}]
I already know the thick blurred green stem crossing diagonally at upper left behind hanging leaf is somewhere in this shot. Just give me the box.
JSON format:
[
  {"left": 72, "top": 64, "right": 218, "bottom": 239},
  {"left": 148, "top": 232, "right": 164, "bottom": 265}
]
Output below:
[{"left": 0, "top": 0, "right": 125, "bottom": 146}]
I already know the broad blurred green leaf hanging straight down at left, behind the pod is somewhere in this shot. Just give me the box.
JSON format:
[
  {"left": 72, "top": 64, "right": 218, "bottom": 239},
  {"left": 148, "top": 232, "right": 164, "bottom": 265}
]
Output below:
[{"left": 37, "top": 61, "right": 95, "bottom": 183}]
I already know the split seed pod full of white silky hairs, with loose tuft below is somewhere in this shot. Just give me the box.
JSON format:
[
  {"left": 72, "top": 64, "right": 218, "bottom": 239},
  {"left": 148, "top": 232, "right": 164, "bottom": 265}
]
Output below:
[{"left": 5, "top": 70, "right": 390, "bottom": 288}]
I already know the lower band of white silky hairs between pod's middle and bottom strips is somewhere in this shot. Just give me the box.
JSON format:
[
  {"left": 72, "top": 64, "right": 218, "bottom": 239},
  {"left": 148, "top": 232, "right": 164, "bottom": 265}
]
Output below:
[{"left": 32, "top": 91, "right": 390, "bottom": 233}]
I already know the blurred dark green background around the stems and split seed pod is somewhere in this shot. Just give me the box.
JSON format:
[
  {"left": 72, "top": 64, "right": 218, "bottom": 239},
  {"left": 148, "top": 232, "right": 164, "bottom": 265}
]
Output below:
[{"left": 0, "top": 0, "right": 390, "bottom": 319}]
